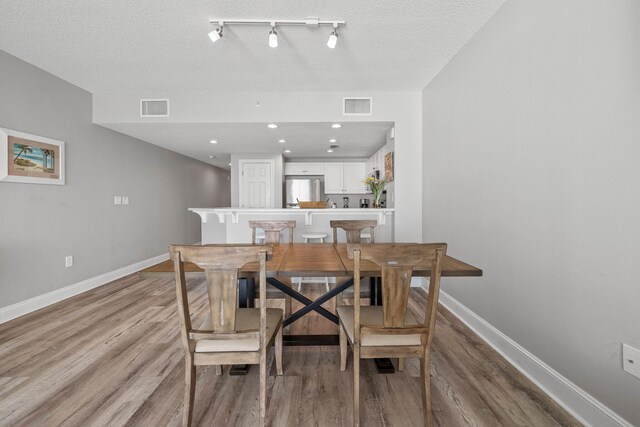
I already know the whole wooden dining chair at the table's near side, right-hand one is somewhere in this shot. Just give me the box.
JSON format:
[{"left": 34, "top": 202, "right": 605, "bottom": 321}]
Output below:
[{"left": 338, "top": 243, "right": 447, "bottom": 426}]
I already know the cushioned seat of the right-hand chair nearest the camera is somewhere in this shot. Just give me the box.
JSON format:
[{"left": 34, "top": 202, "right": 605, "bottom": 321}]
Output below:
[{"left": 338, "top": 305, "right": 422, "bottom": 347}]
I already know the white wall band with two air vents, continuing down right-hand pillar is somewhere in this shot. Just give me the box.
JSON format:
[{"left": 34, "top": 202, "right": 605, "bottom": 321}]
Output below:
[{"left": 93, "top": 92, "right": 422, "bottom": 241}]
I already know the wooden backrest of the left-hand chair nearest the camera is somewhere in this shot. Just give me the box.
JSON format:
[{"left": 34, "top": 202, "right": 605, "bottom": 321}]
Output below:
[{"left": 169, "top": 245, "right": 273, "bottom": 352}]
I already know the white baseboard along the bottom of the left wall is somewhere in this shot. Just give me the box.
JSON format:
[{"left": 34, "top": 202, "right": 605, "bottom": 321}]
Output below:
[{"left": 0, "top": 253, "right": 169, "bottom": 323}]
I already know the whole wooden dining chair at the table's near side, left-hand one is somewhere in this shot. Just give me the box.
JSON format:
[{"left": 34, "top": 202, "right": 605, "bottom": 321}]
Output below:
[{"left": 169, "top": 245, "right": 282, "bottom": 426}]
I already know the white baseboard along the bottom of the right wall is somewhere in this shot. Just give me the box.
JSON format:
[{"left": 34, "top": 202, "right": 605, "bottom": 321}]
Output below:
[{"left": 440, "top": 291, "right": 632, "bottom": 427}]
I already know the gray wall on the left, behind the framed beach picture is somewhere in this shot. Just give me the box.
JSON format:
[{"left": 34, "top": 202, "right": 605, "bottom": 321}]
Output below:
[{"left": 0, "top": 51, "right": 230, "bottom": 308}]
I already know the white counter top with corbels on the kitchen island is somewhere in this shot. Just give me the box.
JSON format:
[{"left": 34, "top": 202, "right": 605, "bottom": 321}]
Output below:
[{"left": 189, "top": 208, "right": 395, "bottom": 225}]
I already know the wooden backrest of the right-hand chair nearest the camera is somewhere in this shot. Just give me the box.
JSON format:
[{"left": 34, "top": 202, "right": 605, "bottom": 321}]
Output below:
[{"left": 347, "top": 243, "right": 447, "bottom": 349}]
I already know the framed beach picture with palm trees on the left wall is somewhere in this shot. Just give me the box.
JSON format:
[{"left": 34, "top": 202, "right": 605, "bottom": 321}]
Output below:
[{"left": 0, "top": 128, "right": 64, "bottom": 185}]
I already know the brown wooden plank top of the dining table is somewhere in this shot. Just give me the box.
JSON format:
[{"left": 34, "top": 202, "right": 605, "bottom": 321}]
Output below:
[{"left": 139, "top": 243, "right": 482, "bottom": 277}]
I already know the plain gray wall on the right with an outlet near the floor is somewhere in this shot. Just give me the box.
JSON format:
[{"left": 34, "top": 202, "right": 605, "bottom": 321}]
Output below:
[{"left": 423, "top": 0, "right": 640, "bottom": 425}]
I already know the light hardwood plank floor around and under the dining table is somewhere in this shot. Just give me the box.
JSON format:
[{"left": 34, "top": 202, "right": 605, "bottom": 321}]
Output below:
[{"left": 0, "top": 275, "right": 579, "bottom": 427}]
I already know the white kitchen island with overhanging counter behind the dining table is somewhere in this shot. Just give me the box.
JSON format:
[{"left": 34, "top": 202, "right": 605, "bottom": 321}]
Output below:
[{"left": 189, "top": 208, "right": 395, "bottom": 244}]
